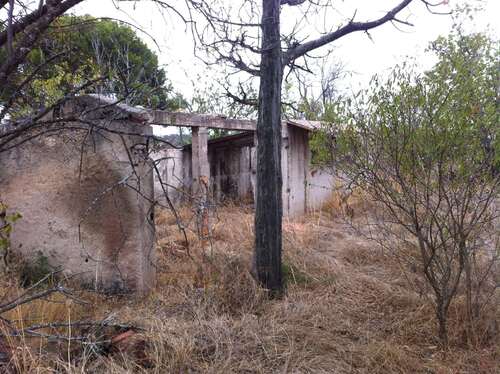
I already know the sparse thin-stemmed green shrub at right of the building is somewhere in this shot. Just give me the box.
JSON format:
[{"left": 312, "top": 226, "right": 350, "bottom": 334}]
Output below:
[{"left": 316, "top": 29, "right": 500, "bottom": 344}]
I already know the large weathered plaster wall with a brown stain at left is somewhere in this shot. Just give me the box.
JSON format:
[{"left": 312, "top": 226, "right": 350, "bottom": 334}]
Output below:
[{"left": 0, "top": 121, "right": 155, "bottom": 292}]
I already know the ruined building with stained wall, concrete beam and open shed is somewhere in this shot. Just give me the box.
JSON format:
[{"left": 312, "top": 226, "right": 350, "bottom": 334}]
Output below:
[{"left": 0, "top": 95, "right": 332, "bottom": 293}]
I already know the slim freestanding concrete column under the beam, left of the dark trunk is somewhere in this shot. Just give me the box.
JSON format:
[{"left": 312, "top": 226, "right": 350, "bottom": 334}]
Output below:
[{"left": 191, "top": 127, "right": 210, "bottom": 194}]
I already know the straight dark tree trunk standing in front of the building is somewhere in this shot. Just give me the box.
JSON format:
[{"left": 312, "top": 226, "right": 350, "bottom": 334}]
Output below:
[{"left": 254, "top": 0, "right": 283, "bottom": 296}]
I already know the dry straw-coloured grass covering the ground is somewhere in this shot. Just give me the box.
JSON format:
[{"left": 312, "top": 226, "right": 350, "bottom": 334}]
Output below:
[{"left": 0, "top": 202, "right": 500, "bottom": 374}]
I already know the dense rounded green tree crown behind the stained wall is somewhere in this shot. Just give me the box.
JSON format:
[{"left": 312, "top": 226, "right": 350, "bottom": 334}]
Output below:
[{"left": 0, "top": 16, "right": 186, "bottom": 114}]
